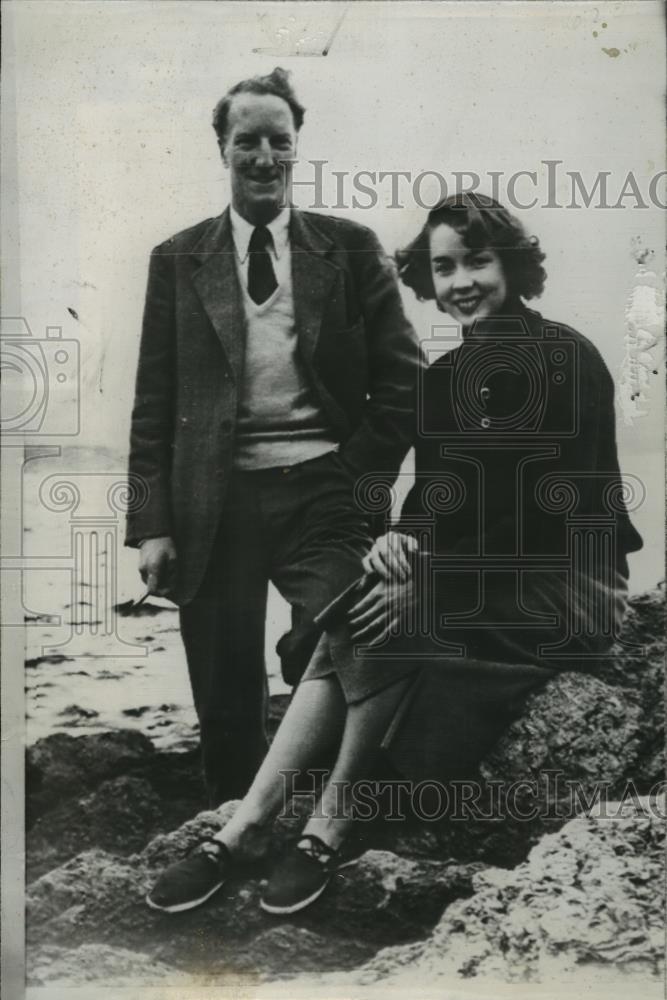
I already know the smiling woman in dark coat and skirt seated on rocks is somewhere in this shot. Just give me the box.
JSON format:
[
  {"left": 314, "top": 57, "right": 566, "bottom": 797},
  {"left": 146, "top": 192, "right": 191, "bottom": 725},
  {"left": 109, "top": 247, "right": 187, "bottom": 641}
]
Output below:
[{"left": 148, "top": 194, "right": 642, "bottom": 913}]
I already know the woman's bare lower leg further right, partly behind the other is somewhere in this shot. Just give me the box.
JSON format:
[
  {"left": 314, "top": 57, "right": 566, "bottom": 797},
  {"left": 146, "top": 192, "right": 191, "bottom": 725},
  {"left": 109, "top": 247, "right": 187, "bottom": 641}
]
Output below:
[{"left": 303, "top": 677, "right": 412, "bottom": 850}]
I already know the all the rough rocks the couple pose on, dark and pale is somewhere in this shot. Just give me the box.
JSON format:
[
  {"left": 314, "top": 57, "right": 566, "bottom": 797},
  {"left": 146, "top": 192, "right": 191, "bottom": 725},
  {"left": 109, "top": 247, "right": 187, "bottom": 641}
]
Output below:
[{"left": 27, "top": 591, "right": 664, "bottom": 985}]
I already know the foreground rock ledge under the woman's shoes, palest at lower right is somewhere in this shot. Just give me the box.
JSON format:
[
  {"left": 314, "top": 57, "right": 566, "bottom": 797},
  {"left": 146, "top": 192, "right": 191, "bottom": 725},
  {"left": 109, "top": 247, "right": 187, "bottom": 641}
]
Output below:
[{"left": 23, "top": 797, "right": 665, "bottom": 996}]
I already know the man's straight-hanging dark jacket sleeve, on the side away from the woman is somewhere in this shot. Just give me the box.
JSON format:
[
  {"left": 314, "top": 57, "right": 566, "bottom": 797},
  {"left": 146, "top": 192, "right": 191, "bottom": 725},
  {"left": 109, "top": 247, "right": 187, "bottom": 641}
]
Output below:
[{"left": 125, "top": 245, "right": 175, "bottom": 546}]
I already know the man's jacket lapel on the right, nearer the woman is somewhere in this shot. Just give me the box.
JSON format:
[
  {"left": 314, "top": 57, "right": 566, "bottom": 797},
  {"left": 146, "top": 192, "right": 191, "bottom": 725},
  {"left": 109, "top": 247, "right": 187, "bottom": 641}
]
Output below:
[{"left": 290, "top": 209, "right": 338, "bottom": 370}]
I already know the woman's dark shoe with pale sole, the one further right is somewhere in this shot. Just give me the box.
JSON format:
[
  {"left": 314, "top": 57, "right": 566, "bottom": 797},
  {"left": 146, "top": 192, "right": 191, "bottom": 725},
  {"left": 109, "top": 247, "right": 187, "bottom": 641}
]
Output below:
[{"left": 259, "top": 833, "right": 352, "bottom": 913}]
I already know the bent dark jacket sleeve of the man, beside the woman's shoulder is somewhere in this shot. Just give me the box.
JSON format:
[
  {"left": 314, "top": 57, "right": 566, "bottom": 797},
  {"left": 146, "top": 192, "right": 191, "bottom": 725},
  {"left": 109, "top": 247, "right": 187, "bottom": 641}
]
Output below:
[{"left": 340, "top": 228, "right": 424, "bottom": 478}]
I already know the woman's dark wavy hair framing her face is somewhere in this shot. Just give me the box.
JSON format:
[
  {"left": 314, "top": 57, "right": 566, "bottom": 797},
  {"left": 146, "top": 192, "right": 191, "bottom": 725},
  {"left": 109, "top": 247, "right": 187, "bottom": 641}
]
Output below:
[{"left": 396, "top": 191, "right": 547, "bottom": 301}]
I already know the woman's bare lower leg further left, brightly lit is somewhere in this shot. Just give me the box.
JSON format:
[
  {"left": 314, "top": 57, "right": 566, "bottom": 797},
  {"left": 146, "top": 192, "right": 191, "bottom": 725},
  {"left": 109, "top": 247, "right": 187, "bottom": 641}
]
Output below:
[{"left": 216, "top": 674, "right": 346, "bottom": 857}]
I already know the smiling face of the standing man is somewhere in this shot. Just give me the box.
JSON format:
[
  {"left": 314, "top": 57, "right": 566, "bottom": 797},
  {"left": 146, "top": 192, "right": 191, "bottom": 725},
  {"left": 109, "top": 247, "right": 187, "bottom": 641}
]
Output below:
[{"left": 222, "top": 94, "right": 296, "bottom": 225}]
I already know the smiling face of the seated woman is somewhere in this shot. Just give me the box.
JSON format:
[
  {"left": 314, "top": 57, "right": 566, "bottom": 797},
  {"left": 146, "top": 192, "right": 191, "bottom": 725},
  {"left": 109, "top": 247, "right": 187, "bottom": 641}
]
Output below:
[{"left": 430, "top": 223, "right": 507, "bottom": 329}]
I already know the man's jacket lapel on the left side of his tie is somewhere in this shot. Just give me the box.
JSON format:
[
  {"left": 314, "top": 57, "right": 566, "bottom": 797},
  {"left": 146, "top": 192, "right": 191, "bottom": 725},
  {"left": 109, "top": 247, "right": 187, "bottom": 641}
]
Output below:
[{"left": 192, "top": 209, "right": 246, "bottom": 382}]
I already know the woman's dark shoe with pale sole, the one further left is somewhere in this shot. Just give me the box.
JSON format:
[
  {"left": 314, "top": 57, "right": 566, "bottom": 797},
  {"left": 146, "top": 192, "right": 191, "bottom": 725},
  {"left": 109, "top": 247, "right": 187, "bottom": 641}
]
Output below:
[{"left": 146, "top": 837, "right": 234, "bottom": 913}]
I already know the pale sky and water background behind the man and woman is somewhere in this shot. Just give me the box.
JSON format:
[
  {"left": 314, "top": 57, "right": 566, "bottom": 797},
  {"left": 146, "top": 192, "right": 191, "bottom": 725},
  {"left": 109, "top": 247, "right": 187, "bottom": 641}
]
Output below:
[{"left": 2, "top": 0, "right": 665, "bottom": 992}]
